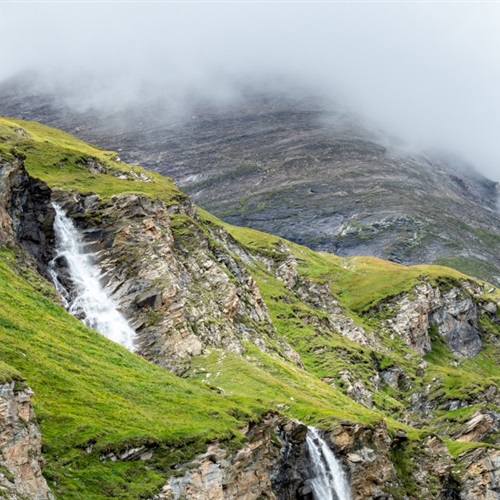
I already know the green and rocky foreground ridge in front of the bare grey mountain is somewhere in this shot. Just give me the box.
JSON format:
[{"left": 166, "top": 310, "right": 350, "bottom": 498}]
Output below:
[{"left": 0, "top": 119, "right": 500, "bottom": 498}]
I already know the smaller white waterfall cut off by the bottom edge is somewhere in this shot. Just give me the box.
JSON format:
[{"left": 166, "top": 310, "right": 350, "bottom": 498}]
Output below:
[{"left": 306, "top": 427, "right": 351, "bottom": 500}]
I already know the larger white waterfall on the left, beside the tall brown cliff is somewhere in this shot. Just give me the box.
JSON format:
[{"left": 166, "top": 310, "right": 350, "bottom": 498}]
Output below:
[{"left": 49, "top": 204, "right": 135, "bottom": 351}]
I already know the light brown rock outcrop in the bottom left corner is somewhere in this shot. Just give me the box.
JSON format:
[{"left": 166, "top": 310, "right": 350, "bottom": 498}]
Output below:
[{"left": 0, "top": 381, "right": 54, "bottom": 500}]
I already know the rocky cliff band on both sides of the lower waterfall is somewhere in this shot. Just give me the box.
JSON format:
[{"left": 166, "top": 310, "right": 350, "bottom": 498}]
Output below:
[{"left": 154, "top": 415, "right": 488, "bottom": 500}]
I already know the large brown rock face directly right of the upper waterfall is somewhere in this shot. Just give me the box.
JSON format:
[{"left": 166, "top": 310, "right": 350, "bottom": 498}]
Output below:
[{"left": 53, "top": 191, "right": 300, "bottom": 373}]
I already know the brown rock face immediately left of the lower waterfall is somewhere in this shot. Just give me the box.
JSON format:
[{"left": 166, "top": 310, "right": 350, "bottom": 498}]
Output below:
[{"left": 154, "top": 415, "right": 346, "bottom": 500}]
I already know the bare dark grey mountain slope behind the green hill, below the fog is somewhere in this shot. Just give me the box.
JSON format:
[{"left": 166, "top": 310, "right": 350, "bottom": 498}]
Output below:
[{"left": 0, "top": 79, "right": 500, "bottom": 284}]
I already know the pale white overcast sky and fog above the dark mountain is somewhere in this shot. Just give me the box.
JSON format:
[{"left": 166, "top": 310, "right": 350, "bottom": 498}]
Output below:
[{"left": 0, "top": 1, "right": 500, "bottom": 181}]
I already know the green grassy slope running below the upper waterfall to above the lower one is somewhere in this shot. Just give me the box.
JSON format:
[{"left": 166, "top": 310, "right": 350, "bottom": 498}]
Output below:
[{"left": 0, "top": 242, "right": 418, "bottom": 499}]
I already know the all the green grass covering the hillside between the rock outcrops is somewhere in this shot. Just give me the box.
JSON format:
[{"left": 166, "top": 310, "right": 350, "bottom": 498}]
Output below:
[{"left": 0, "top": 119, "right": 500, "bottom": 499}]
